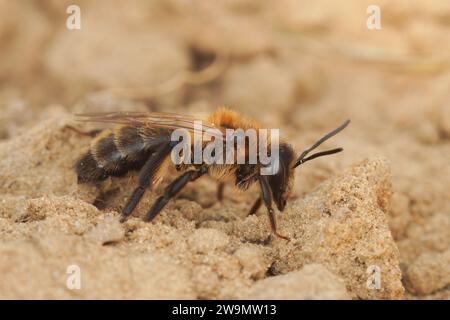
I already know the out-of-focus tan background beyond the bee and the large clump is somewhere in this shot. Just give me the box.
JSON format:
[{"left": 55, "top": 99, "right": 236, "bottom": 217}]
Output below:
[{"left": 0, "top": 0, "right": 450, "bottom": 294}]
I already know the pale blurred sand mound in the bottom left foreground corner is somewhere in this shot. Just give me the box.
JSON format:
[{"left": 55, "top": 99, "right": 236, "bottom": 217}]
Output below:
[{"left": 0, "top": 235, "right": 195, "bottom": 299}]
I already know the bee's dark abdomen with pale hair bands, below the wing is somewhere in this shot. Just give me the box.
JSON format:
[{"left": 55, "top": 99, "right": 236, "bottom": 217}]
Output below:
[{"left": 75, "top": 127, "right": 162, "bottom": 183}]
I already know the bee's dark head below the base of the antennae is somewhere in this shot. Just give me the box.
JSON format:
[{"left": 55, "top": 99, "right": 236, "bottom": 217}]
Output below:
[{"left": 268, "top": 143, "right": 295, "bottom": 211}]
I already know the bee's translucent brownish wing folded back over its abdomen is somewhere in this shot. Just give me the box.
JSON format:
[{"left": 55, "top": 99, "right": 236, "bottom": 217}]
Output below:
[{"left": 76, "top": 112, "right": 224, "bottom": 139}]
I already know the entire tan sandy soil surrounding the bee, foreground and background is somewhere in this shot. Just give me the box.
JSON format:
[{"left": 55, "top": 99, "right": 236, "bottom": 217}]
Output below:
[{"left": 0, "top": 0, "right": 450, "bottom": 299}]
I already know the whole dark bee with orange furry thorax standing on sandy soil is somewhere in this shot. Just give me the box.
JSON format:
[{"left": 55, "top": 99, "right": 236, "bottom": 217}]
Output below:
[{"left": 75, "top": 108, "right": 350, "bottom": 239}]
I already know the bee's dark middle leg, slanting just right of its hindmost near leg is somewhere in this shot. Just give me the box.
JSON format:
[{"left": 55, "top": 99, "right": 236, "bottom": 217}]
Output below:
[{"left": 144, "top": 167, "right": 207, "bottom": 221}]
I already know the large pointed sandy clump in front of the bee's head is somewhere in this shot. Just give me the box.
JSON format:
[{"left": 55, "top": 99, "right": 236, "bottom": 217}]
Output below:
[{"left": 272, "top": 159, "right": 403, "bottom": 299}]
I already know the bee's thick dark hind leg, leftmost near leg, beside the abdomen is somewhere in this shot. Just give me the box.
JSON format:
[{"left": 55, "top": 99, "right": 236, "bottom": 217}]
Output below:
[{"left": 121, "top": 143, "right": 172, "bottom": 221}]
